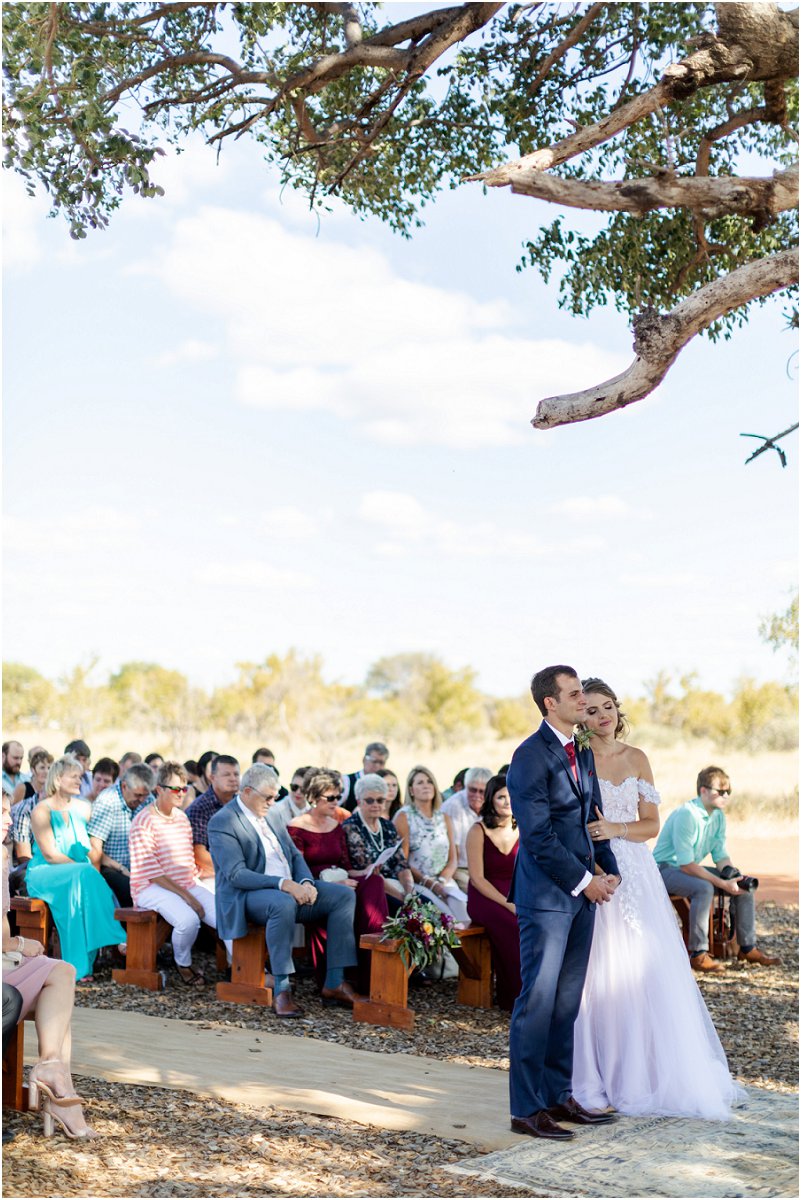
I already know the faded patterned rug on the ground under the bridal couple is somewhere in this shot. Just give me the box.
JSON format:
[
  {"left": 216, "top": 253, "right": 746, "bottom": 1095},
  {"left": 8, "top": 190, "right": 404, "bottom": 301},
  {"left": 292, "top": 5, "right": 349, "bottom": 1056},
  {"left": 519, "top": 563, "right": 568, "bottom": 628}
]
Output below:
[{"left": 446, "top": 1087, "right": 799, "bottom": 1198}]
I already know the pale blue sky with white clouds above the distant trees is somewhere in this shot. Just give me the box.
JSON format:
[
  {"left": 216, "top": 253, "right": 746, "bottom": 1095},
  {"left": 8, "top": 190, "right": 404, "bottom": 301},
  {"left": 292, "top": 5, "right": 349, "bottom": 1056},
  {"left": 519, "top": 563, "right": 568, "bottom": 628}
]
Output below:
[{"left": 4, "top": 106, "right": 799, "bottom": 695}]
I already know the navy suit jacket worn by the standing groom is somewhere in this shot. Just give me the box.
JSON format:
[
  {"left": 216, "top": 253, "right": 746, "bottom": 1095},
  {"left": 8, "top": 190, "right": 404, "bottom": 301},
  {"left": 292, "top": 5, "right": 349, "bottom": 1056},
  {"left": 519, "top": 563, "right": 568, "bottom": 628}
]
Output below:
[{"left": 506, "top": 721, "right": 620, "bottom": 912}]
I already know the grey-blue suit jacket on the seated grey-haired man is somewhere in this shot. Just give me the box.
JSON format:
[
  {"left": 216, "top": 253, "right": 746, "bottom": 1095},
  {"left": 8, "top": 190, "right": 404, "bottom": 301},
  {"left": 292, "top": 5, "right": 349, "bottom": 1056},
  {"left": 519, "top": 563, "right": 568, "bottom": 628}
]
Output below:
[{"left": 209, "top": 800, "right": 314, "bottom": 937}]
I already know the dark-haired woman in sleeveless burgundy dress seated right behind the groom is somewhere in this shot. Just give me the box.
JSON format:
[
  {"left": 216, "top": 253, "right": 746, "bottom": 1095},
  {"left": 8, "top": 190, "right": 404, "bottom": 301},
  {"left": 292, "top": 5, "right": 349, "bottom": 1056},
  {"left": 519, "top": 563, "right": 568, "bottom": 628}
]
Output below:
[{"left": 468, "top": 775, "right": 522, "bottom": 1013}]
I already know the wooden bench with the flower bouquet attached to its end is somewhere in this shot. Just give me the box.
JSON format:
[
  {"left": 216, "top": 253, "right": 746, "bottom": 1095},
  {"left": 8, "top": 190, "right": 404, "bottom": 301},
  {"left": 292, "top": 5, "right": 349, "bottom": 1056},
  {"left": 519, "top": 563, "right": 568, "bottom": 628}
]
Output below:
[{"left": 354, "top": 925, "right": 493, "bottom": 1030}]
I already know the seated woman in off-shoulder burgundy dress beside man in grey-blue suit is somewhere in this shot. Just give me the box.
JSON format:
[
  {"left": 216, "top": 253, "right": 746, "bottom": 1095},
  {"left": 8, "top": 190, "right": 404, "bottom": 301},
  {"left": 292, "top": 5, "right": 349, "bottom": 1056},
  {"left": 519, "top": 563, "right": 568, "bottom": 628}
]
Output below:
[{"left": 287, "top": 768, "right": 389, "bottom": 984}]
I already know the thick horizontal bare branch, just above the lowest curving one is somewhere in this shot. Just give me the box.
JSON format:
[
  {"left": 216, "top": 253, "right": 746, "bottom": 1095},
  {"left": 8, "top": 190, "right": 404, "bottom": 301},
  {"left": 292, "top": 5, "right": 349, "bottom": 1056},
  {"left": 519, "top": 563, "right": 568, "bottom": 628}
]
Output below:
[{"left": 501, "top": 167, "right": 799, "bottom": 220}]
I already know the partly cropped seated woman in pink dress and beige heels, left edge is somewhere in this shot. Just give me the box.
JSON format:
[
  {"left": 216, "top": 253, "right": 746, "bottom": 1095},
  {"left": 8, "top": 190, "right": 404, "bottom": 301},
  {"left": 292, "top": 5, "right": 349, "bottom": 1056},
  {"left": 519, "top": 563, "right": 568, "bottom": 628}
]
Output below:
[{"left": 2, "top": 792, "right": 100, "bottom": 1138}]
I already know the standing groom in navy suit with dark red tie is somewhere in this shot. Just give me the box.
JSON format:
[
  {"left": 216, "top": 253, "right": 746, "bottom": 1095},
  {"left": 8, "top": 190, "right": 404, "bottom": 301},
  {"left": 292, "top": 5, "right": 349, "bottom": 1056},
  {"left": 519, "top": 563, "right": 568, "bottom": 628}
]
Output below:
[{"left": 507, "top": 666, "right": 620, "bottom": 1139}]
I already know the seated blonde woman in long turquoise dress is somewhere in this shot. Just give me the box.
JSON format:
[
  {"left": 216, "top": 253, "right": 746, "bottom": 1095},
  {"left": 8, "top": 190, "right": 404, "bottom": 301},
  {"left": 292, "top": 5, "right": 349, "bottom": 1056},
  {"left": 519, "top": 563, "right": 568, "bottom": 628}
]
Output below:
[{"left": 25, "top": 755, "right": 125, "bottom": 983}]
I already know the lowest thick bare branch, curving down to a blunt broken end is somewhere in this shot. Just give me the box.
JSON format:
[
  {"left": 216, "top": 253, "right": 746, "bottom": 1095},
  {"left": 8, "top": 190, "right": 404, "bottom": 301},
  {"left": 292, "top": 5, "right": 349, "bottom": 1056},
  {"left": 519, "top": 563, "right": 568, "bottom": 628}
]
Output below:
[{"left": 531, "top": 250, "right": 799, "bottom": 430}]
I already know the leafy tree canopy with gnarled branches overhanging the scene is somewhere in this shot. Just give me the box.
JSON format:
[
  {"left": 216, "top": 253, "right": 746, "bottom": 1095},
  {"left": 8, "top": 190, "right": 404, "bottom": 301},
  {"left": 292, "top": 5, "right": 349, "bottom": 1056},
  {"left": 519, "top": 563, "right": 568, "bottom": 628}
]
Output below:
[{"left": 4, "top": 2, "right": 799, "bottom": 427}]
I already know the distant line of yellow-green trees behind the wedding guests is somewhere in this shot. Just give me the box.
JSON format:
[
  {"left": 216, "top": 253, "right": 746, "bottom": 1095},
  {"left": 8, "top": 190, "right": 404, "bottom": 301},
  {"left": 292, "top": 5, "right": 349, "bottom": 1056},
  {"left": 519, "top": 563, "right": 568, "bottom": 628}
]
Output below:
[{"left": 2, "top": 649, "right": 797, "bottom": 751}]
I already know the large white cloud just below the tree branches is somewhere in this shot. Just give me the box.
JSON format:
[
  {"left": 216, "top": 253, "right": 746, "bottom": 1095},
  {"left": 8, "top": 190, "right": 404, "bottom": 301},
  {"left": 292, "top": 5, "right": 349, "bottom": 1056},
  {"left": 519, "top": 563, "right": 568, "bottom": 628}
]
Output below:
[{"left": 134, "top": 208, "right": 624, "bottom": 448}]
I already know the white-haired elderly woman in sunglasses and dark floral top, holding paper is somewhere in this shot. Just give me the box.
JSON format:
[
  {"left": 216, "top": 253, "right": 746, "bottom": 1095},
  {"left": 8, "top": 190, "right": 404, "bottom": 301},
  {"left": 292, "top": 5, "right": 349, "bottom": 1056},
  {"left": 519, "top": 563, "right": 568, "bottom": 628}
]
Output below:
[{"left": 340, "top": 772, "right": 415, "bottom": 907}]
